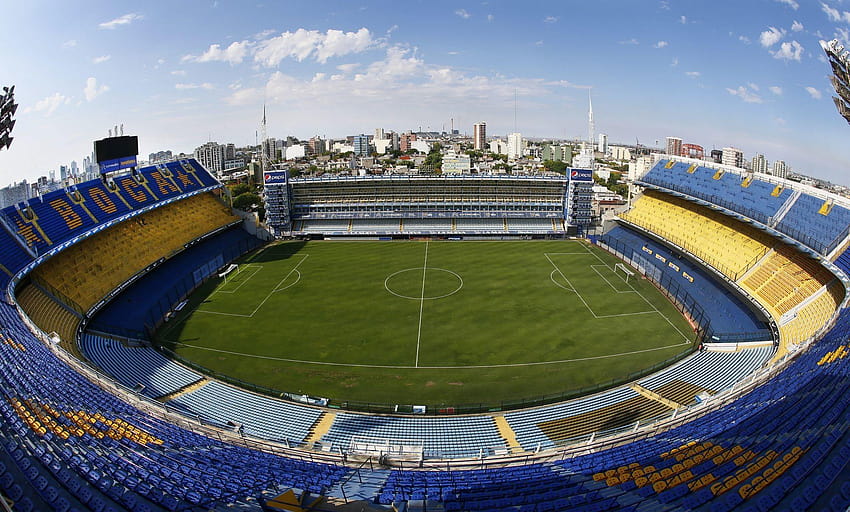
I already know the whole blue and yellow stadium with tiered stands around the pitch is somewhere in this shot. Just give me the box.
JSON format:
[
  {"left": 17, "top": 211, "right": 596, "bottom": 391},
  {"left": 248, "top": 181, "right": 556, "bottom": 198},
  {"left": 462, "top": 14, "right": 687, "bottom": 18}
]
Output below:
[{"left": 0, "top": 52, "right": 850, "bottom": 512}]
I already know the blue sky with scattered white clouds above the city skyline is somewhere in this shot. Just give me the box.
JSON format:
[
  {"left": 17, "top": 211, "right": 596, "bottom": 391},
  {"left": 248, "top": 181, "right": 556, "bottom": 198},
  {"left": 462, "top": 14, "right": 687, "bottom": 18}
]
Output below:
[{"left": 0, "top": 0, "right": 850, "bottom": 186}]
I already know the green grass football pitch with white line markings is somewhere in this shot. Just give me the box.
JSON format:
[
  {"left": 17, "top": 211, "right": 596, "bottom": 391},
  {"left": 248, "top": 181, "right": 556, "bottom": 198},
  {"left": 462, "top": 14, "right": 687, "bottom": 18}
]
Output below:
[{"left": 157, "top": 241, "right": 694, "bottom": 405}]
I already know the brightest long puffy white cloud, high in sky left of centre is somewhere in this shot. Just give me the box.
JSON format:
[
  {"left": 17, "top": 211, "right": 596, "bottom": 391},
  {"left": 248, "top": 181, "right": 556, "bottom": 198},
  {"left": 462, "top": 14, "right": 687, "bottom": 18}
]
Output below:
[{"left": 254, "top": 28, "right": 377, "bottom": 67}]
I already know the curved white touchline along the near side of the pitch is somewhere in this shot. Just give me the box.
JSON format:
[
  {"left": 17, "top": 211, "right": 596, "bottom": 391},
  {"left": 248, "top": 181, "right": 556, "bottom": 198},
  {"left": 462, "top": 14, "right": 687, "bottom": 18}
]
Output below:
[{"left": 169, "top": 341, "right": 690, "bottom": 370}]
